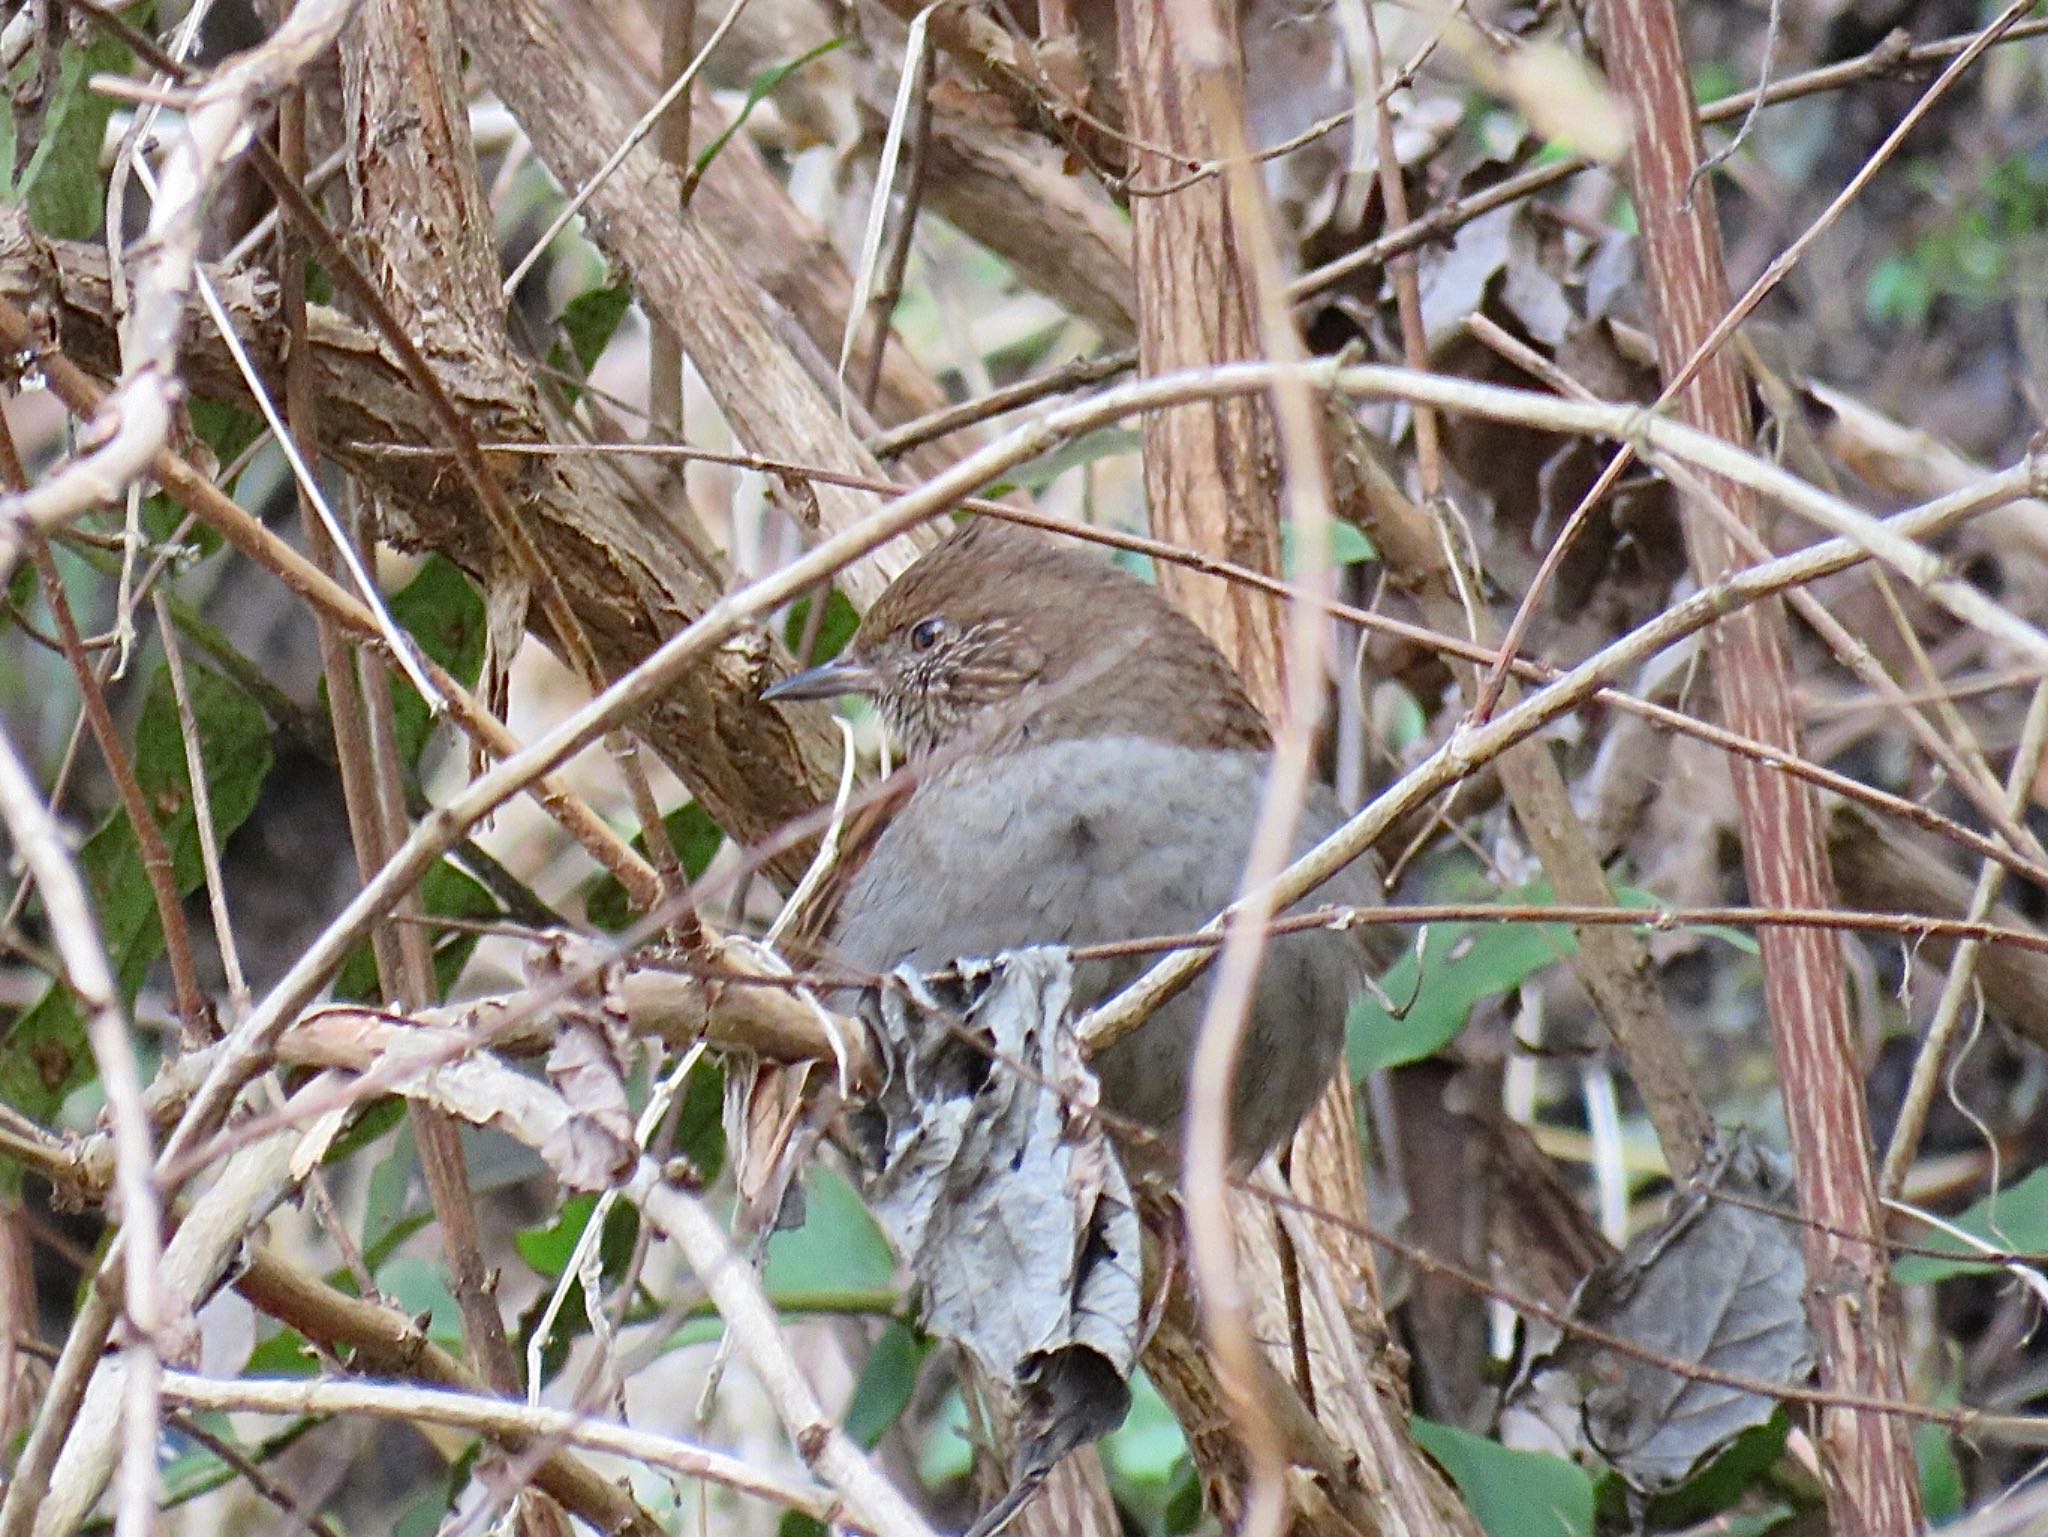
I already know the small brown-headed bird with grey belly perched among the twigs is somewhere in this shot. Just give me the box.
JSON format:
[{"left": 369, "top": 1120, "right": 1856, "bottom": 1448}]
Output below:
[{"left": 762, "top": 521, "right": 1378, "bottom": 1166}]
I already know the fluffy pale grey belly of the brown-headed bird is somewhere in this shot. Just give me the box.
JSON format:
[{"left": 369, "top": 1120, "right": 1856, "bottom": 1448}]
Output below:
[{"left": 834, "top": 738, "right": 1376, "bottom": 1164}]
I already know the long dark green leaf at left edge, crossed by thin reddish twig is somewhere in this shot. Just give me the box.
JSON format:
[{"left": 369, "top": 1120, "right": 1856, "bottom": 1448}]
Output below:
[{"left": 0, "top": 666, "right": 270, "bottom": 1121}]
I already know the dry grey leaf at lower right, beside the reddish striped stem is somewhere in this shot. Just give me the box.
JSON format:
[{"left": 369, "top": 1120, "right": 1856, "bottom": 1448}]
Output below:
[{"left": 1544, "top": 1131, "right": 1815, "bottom": 1494}]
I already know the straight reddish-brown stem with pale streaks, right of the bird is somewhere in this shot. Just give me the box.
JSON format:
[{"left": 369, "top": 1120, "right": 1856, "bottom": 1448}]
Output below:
[{"left": 1599, "top": 0, "right": 1921, "bottom": 1537}]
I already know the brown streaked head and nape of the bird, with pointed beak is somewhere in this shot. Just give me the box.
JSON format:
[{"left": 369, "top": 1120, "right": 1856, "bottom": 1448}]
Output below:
[{"left": 762, "top": 518, "right": 1266, "bottom": 758}]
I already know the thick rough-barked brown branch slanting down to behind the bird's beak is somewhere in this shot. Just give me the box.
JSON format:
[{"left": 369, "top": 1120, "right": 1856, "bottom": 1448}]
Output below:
[{"left": 0, "top": 209, "right": 838, "bottom": 887}]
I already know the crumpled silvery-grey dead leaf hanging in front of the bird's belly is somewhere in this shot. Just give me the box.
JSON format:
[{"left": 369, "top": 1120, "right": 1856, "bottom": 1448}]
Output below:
[{"left": 868, "top": 949, "right": 1141, "bottom": 1482}]
